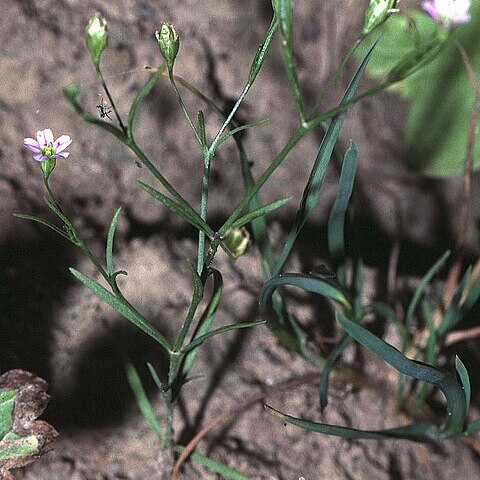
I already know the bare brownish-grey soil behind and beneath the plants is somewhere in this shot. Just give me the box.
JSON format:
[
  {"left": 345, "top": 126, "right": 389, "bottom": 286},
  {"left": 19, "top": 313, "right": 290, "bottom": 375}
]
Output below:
[{"left": 0, "top": 0, "right": 480, "bottom": 480}]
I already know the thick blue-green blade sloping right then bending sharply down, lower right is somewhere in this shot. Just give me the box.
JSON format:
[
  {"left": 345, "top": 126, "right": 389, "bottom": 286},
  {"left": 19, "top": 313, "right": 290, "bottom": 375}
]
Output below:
[{"left": 336, "top": 312, "right": 467, "bottom": 438}]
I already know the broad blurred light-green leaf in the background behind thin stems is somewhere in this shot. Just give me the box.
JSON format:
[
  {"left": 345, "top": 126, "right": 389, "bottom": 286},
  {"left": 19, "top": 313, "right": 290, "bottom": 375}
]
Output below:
[{"left": 359, "top": 7, "right": 480, "bottom": 176}]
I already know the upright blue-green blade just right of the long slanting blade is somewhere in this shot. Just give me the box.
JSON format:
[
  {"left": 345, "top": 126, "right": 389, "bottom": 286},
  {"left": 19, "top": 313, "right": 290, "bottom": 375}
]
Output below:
[{"left": 328, "top": 142, "right": 358, "bottom": 283}]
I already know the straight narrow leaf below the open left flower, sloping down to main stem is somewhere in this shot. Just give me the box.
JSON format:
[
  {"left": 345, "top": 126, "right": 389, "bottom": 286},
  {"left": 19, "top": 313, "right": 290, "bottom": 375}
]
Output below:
[{"left": 69, "top": 268, "right": 172, "bottom": 352}]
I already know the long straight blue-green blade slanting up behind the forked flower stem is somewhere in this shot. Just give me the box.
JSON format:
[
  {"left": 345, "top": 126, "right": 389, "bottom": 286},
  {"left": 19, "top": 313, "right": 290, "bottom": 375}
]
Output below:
[{"left": 274, "top": 47, "right": 373, "bottom": 274}]
